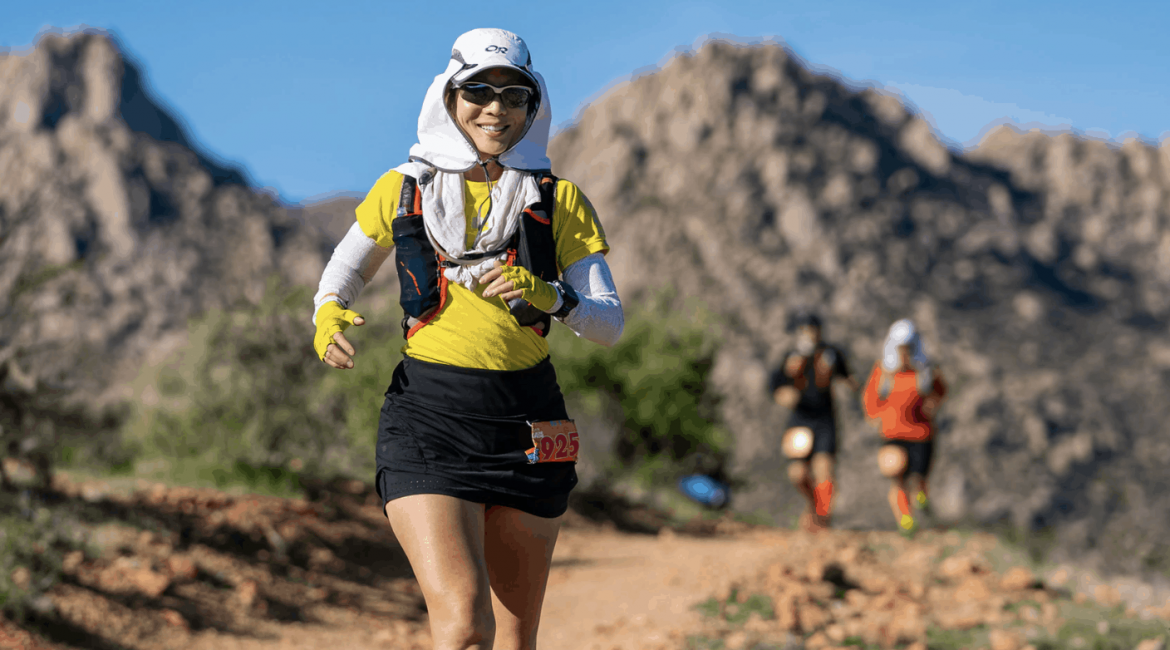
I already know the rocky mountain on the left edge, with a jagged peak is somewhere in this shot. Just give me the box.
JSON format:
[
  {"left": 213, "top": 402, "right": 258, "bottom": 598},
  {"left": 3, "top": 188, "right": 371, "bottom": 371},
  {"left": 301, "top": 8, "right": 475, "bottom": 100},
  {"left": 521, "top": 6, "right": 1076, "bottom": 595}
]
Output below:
[{"left": 0, "top": 33, "right": 328, "bottom": 451}]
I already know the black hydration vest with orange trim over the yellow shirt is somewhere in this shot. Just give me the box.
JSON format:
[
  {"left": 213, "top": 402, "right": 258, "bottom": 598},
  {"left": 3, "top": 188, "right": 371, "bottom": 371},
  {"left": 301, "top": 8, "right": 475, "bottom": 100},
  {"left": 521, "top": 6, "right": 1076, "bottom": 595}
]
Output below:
[{"left": 391, "top": 174, "right": 558, "bottom": 339}]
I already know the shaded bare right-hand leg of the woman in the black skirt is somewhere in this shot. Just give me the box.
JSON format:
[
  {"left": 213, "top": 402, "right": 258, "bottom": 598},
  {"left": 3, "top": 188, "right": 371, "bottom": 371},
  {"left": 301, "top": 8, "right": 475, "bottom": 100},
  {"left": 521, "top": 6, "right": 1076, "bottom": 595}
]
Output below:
[{"left": 483, "top": 506, "right": 560, "bottom": 650}]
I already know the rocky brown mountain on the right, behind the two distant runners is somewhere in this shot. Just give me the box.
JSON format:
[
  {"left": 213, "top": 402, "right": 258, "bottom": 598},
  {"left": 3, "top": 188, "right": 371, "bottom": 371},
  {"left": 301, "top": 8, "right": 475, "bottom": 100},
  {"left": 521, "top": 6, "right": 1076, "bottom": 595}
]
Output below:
[{"left": 551, "top": 42, "right": 1170, "bottom": 579}]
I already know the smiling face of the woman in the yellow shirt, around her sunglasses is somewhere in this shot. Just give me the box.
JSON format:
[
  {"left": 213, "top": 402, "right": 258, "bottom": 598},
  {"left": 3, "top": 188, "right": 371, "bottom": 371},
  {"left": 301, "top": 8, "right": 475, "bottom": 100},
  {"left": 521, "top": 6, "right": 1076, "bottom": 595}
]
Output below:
[{"left": 448, "top": 68, "right": 532, "bottom": 158}]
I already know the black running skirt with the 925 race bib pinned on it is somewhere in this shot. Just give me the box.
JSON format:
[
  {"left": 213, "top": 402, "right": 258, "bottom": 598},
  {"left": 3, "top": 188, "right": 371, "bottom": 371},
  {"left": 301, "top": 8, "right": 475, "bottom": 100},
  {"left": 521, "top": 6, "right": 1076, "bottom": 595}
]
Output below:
[{"left": 374, "top": 357, "right": 575, "bottom": 518}]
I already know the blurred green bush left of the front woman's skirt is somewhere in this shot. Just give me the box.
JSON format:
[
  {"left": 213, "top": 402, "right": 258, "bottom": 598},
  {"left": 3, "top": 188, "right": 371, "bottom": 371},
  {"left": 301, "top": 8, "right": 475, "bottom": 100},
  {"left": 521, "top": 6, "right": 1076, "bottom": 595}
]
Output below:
[{"left": 124, "top": 281, "right": 398, "bottom": 492}]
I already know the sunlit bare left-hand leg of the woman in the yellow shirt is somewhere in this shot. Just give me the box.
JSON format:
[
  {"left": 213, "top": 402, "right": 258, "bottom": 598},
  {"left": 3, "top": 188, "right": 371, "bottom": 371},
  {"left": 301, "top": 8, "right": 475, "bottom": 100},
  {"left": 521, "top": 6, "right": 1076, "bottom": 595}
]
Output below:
[{"left": 386, "top": 495, "right": 496, "bottom": 650}]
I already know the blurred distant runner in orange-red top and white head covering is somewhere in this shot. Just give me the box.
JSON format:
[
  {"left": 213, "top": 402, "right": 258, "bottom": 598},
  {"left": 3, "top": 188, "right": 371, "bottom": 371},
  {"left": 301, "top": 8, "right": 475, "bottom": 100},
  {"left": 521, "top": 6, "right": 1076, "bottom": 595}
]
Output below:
[{"left": 862, "top": 319, "right": 947, "bottom": 534}]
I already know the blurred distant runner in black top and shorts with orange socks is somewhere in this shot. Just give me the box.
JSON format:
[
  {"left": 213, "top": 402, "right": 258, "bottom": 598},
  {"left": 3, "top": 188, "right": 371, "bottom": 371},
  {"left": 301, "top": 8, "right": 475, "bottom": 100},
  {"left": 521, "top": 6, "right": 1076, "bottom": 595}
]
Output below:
[{"left": 771, "top": 312, "right": 859, "bottom": 531}]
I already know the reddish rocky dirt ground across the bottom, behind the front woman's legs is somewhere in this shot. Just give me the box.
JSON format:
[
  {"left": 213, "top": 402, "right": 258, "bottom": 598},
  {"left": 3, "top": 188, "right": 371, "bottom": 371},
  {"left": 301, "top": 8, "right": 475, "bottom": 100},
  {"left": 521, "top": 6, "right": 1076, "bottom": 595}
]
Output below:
[{"left": 0, "top": 476, "right": 1170, "bottom": 650}]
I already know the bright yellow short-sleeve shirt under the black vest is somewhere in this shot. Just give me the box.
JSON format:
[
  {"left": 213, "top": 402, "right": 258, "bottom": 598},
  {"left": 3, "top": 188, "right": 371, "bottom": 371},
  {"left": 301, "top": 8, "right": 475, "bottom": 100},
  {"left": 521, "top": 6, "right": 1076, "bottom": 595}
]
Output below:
[{"left": 357, "top": 171, "right": 610, "bottom": 371}]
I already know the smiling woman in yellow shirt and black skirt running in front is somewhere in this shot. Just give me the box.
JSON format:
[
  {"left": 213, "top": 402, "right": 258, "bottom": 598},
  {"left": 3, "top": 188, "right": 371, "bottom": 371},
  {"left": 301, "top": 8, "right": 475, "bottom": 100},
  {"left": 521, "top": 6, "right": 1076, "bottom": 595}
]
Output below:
[{"left": 314, "top": 29, "right": 624, "bottom": 649}]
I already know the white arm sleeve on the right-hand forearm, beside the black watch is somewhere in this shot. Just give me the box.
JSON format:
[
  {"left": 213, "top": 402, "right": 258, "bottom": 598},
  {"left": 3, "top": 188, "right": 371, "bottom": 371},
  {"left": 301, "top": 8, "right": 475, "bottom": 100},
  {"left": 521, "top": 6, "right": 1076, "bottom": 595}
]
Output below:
[{"left": 552, "top": 253, "right": 626, "bottom": 347}]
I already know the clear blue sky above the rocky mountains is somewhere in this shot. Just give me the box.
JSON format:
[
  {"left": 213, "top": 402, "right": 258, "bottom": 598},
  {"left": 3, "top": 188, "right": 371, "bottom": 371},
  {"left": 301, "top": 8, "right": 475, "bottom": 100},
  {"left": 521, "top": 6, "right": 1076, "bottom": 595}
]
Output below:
[{"left": 0, "top": 0, "right": 1170, "bottom": 201}]
